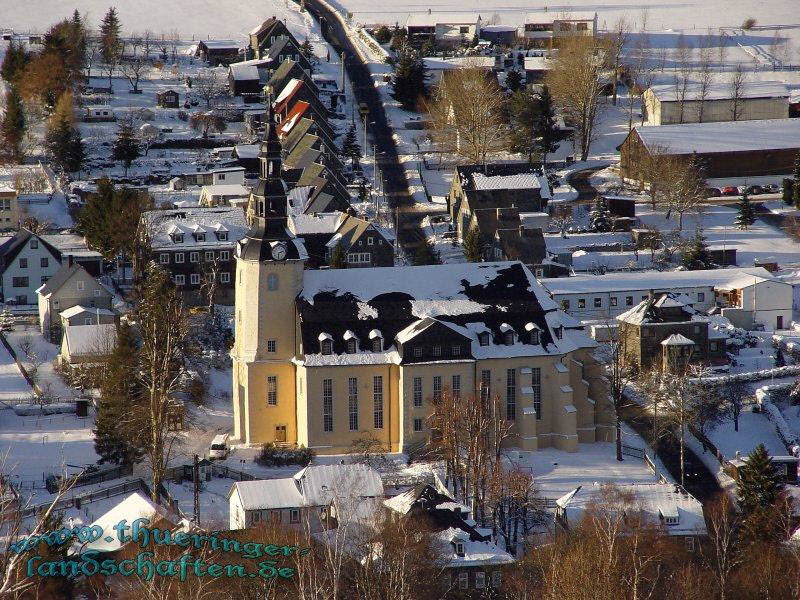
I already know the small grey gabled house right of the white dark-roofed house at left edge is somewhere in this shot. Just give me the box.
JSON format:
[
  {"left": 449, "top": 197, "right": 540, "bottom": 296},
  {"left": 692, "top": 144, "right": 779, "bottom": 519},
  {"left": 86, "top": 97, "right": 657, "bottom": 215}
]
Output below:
[{"left": 36, "top": 256, "right": 114, "bottom": 341}]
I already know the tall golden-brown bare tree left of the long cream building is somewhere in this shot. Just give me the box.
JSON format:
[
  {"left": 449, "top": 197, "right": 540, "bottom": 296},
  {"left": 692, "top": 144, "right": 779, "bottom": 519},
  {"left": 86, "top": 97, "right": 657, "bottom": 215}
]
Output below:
[{"left": 545, "top": 36, "right": 606, "bottom": 160}]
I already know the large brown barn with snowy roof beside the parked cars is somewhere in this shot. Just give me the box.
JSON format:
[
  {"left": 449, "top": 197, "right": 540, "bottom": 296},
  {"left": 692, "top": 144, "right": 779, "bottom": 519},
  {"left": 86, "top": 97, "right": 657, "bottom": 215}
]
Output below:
[{"left": 620, "top": 119, "right": 800, "bottom": 179}]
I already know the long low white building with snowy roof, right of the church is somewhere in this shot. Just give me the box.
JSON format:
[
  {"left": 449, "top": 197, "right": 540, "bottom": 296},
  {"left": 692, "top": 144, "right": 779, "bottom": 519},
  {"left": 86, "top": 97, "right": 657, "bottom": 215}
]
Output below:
[{"left": 539, "top": 267, "right": 793, "bottom": 331}]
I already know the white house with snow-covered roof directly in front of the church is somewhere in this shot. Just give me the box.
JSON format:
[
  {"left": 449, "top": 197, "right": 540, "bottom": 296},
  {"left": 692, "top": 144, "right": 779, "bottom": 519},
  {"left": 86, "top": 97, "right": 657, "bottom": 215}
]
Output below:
[{"left": 228, "top": 464, "right": 383, "bottom": 532}]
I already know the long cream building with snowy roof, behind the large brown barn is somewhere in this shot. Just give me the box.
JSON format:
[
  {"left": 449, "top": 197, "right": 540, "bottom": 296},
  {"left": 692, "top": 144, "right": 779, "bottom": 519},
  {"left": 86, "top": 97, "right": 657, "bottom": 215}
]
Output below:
[{"left": 642, "top": 81, "right": 789, "bottom": 125}]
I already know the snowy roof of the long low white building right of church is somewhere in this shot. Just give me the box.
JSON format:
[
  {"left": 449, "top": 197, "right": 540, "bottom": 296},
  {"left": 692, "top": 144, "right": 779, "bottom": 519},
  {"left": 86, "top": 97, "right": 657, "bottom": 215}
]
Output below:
[{"left": 539, "top": 267, "right": 780, "bottom": 295}]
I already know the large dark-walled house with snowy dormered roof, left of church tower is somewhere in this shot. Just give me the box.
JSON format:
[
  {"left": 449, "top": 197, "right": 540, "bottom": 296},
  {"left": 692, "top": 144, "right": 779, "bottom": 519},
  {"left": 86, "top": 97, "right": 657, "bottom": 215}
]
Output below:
[{"left": 140, "top": 207, "right": 247, "bottom": 305}]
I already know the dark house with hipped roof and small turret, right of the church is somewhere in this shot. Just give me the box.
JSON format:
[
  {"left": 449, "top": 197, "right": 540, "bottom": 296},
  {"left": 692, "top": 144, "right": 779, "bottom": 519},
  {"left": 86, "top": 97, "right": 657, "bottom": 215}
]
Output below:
[{"left": 617, "top": 292, "right": 728, "bottom": 371}]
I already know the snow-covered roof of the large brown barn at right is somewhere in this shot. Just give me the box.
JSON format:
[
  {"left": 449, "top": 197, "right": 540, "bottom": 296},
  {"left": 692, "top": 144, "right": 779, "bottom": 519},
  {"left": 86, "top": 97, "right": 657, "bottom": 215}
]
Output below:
[{"left": 634, "top": 119, "right": 800, "bottom": 154}]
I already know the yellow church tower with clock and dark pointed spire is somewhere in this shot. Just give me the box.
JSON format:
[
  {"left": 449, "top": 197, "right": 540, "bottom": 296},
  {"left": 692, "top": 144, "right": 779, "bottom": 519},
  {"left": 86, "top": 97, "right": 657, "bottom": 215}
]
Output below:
[{"left": 231, "top": 106, "right": 307, "bottom": 443}]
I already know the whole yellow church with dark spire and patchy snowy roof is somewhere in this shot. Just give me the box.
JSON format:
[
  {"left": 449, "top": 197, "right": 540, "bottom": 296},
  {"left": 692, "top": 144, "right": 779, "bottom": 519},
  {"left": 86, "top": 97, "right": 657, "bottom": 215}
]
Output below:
[{"left": 231, "top": 115, "right": 613, "bottom": 454}]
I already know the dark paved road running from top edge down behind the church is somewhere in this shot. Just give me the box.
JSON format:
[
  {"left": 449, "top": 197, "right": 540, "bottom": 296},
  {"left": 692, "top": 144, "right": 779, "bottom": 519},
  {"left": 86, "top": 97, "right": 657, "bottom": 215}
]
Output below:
[{"left": 306, "top": 0, "right": 422, "bottom": 248}]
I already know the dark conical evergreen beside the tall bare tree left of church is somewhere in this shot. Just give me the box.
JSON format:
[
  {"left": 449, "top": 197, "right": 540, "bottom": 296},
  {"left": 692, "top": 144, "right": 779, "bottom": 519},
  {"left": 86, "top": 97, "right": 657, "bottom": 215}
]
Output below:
[{"left": 94, "top": 323, "right": 143, "bottom": 465}]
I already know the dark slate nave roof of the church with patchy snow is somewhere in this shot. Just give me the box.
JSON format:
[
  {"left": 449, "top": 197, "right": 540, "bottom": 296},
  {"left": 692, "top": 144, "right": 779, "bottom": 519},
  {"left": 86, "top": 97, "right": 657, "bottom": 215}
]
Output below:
[{"left": 297, "top": 262, "right": 558, "bottom": 353}]
